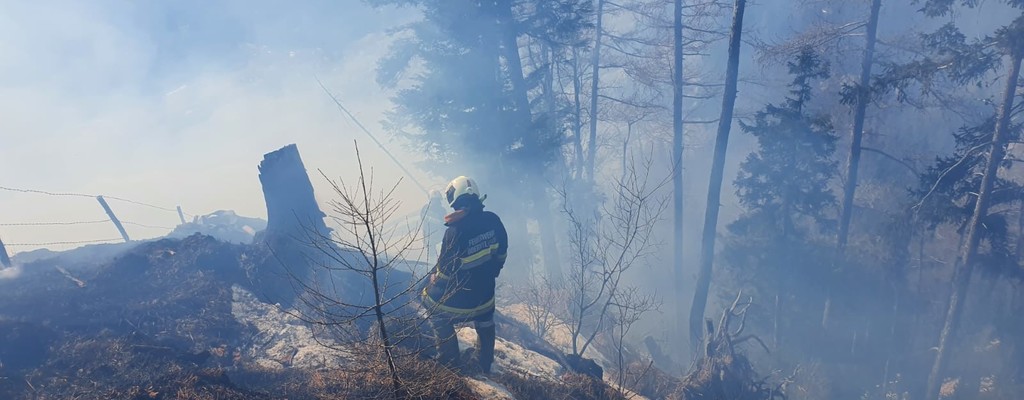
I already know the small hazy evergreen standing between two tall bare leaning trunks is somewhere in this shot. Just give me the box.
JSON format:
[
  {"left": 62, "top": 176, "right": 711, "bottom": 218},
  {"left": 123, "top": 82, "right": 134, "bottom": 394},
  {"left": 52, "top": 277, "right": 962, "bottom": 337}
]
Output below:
[{"left": 724, "top": 49, "right": 838, "bottom": 347}]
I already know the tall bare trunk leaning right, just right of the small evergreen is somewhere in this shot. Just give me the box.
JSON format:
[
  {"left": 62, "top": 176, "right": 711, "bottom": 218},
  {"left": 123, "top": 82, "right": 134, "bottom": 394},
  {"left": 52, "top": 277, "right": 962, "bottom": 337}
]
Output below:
[{"left": 821, "top": 0, "right": 882, "bottom": 327}]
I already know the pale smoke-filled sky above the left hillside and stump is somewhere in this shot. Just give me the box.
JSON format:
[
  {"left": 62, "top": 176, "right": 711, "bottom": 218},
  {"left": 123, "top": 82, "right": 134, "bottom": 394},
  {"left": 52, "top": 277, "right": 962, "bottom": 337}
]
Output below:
[{"left": 0, "top": 0, "right": 434, "bottom": 254}]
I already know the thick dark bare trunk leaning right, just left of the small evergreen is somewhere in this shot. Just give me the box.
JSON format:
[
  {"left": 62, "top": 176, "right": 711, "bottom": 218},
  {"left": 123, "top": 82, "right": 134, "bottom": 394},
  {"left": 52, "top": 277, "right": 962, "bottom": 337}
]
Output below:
[{"left": 690, "top": 0, "right": 746, "bottom": 350}]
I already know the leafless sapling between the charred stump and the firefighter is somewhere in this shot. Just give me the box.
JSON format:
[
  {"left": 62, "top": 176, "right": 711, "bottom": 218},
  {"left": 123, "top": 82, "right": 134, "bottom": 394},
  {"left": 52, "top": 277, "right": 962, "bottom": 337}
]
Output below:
[{"left": 286, "top": 144, "right": 444, "bottom": 398}]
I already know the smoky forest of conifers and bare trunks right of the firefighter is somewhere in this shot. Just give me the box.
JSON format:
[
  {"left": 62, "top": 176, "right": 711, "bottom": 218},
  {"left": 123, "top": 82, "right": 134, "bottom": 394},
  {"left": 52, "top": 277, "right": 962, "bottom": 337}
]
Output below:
[{"left": 370, "top": 0, "right": 1024, "bottom": 399}]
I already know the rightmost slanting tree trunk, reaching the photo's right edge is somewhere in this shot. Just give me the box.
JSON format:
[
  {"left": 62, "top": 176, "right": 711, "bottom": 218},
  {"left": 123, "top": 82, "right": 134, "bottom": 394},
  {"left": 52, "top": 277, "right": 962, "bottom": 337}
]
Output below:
[{"left": 926, "top": 48, "right": 1024, "bottom": 399}]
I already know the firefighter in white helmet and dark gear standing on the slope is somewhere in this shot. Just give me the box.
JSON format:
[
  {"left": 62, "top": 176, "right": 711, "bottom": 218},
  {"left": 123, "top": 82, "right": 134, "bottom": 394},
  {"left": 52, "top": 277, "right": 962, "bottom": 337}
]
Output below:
[{"left": 422, "top": 176, "right": 508, "bottom": 373}]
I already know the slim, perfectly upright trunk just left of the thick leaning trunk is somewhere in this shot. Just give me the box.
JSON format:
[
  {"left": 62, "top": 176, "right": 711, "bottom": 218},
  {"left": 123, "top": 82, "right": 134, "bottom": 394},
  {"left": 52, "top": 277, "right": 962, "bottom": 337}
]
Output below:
[{"left": 672, "top": 0, "right": 686, "bottom": 341}]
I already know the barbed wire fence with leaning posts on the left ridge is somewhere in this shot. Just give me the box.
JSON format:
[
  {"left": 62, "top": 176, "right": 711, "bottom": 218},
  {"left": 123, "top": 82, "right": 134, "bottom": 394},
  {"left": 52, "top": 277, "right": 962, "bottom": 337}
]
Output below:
[{"left": 0, "top": 186, "right": 196, "bottom": 268}]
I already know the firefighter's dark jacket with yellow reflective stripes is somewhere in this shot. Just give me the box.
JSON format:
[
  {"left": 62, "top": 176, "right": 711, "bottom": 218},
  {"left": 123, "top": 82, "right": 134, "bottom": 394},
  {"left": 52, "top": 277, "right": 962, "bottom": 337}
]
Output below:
[{"left": 422, "top": 210, "right": 509, "bottom": 319}]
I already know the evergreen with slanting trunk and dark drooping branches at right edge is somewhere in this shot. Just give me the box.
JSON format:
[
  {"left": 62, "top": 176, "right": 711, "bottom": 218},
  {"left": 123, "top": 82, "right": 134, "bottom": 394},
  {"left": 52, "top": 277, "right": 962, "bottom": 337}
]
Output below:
[{"left": 876, "top": 0, "right": 1024, "bottom": 398}]
